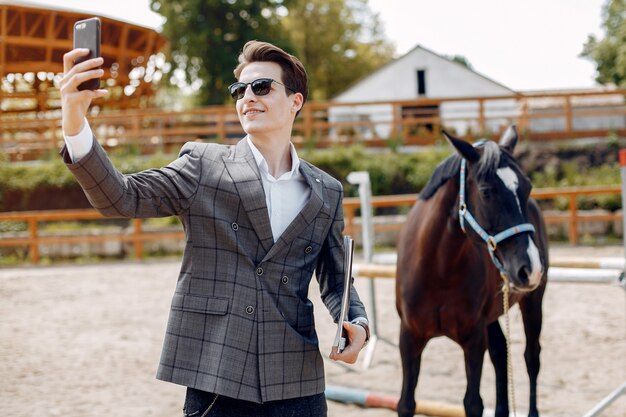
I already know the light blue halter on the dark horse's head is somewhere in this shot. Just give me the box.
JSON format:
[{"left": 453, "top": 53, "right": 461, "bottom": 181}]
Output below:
[{"left": 459, "top": 159, "right": 535, "bottom": 276}]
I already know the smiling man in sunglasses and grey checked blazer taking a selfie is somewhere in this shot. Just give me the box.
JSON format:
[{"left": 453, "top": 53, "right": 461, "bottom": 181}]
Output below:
[{"left": 61, "top": 41, "right": 369, "bottom": 417}]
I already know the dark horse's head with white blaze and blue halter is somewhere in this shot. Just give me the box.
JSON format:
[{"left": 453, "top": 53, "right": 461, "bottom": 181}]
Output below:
[{"left": 443, "top": 126, "right": 543, "bottom": 292}]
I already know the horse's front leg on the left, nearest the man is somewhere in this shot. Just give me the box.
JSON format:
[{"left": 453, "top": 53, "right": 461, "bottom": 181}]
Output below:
[{"left": 398, "top": 323, "right": 426, "bottom": 417}]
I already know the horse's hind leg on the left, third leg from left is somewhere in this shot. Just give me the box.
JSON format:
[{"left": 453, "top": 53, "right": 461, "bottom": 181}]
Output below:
[{"left": 487, "top": 320, "right": 509, "bottom": 417}]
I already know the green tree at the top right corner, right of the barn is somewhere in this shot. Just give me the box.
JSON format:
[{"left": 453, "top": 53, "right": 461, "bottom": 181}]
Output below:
[{"left": 580, "top": 0, "right": 626, "bottom": 87}]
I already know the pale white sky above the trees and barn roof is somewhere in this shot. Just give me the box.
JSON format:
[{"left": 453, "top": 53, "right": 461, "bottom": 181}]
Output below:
[{"left": 24, "top": 0, "right": 607, "bottom": 91}]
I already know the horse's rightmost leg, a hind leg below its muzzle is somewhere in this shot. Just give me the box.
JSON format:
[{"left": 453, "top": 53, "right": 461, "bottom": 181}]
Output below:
[{"left": 519, "top": 287, "right": 543, "bottom": 417}]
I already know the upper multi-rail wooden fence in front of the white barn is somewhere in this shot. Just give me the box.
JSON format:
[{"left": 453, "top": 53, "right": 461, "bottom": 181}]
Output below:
[{"left": 0, "top": 89, "right": 626, "bottom": 160}]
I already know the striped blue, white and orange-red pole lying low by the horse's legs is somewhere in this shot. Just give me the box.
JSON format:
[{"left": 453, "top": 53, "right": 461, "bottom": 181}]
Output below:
[{"left": 325, "top": 385, "right": 465, "bottom": 417}]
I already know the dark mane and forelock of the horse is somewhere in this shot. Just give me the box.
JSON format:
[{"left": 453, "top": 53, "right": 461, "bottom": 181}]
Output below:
[{"left": 419, "top": 141, "right": 505, "bottom": 200}]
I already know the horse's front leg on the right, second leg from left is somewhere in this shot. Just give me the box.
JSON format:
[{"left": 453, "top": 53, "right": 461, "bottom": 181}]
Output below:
[{"left": 463, "top": 326, "right": 487, "bottom": 417}]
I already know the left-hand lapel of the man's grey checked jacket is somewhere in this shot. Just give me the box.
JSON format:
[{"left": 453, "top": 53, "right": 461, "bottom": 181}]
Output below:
[{"left": 224, "top": 139, "right": 274, "bottom": 253}]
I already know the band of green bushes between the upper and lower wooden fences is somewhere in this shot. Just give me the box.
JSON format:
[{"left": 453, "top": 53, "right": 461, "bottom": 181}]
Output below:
[{"left": 0, "top": 144, "right": 621, "bottom": 211}]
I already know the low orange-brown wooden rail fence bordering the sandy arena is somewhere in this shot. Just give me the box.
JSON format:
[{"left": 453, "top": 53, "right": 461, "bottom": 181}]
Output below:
[{"left": 0, "top": 185, "right": 622, "bottom": 264}]
